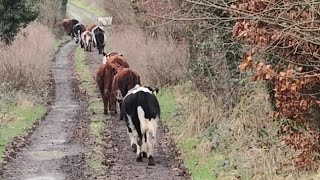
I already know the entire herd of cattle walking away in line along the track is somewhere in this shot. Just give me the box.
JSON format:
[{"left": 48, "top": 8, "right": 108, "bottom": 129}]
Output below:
[{"left": 59, "top": 19, "right": 160, "bottom": 165}]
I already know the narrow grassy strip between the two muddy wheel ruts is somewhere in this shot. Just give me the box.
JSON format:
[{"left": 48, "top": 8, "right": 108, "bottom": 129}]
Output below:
[{"left": 75, "top": 47, "right": 107, "bottom": 174}]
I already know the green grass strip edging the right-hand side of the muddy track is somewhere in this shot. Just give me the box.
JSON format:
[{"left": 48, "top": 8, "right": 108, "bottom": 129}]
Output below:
[{"left": 158, "top": 89, "right": 218, "bottom": 180}]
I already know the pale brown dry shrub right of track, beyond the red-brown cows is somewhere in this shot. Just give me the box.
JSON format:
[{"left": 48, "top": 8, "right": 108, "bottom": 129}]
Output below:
[{"left": 106, "top": 26, "right": 189, "bottom": 86}]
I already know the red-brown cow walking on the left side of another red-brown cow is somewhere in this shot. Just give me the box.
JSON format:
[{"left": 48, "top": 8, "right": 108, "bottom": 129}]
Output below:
[{"left": 95, "top": 63, "right": 117, "bottom": 115}]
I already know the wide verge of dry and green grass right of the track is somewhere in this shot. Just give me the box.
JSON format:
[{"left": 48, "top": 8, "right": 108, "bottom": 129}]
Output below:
[{"left": 158, "top": 83, "right": 303, "bottom": 180}]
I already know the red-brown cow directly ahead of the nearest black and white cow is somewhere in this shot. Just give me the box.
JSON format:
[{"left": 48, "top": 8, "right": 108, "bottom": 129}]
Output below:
[{"left": 112, "top": 66, "right": 141, "bottom": 120}]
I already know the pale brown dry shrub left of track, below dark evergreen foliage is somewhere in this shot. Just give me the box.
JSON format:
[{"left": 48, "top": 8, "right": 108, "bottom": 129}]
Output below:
[{"left": 0, "top": 22, "right": 54, "bottom": 92}]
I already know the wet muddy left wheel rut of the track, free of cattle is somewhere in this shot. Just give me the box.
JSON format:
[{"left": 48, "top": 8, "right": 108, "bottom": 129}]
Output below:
[{"left": 2, "top": 41, "right": 86, "bottom": 180}]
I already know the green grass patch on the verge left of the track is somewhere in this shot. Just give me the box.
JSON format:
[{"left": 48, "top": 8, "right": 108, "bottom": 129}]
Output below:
[{"left": 0, "top": 93, "right": 46, "bottom": 163}]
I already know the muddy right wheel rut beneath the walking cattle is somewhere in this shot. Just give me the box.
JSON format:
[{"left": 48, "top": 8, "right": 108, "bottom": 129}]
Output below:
[{"left": 87, "top": 49, "right": 190, "bottom": 180}]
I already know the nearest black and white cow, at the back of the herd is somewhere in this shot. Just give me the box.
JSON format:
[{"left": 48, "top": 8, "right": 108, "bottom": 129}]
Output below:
[{"left": 120, "top": 84, "right": 160, "bottom": 165}]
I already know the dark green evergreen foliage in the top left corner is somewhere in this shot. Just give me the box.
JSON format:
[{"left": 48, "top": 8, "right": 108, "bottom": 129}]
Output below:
[{"left": 0, "top": 0, "right": 38, "bottom": 44}]
